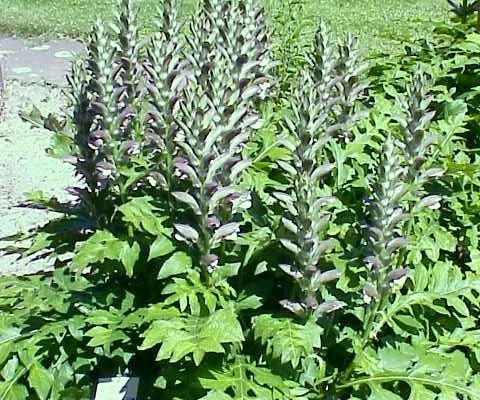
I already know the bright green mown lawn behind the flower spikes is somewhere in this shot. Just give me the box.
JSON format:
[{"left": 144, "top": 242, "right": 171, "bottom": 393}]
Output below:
[{"left": 0, "top": 0, "right": 448, "bottom": 50}]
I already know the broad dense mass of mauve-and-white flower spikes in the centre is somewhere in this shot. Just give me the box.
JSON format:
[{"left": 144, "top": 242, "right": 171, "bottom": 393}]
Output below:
[{"left": 173, "top": 0, "right": 272, "bottom": 280}]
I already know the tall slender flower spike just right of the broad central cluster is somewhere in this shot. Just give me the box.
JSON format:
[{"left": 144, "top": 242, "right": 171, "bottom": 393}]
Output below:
[{"left": 274, "top": 23, "right": 360, "bottom": 317}]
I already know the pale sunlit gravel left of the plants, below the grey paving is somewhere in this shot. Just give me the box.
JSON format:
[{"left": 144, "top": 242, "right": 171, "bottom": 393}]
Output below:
[{"left": 0, "top": 81, "right": 75, "bottom": 275}]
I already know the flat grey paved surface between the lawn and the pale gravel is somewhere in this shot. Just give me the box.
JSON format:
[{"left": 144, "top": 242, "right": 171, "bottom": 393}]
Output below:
[{"left": 0, "top": 35, "right": 84, "bottom": 86}]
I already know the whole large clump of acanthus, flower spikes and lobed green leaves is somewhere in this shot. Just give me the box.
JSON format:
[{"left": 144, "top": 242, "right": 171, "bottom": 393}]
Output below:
[{"left": 0, "top": 0, "right": 480, "bottom": 400}]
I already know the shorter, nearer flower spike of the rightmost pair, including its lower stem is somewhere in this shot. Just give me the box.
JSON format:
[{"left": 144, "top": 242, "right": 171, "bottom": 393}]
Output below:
[{"left": 344, "top": 135, "right": 410, "bottom": 380}]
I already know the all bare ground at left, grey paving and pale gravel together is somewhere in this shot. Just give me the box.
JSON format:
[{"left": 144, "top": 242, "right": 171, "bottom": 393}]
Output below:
[{"left": 0, "top": 37, "right": 81, "bottom": 275}]
